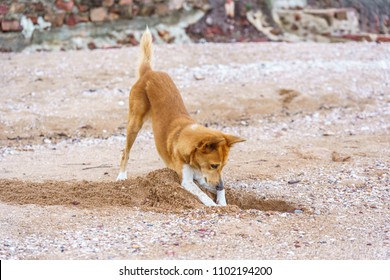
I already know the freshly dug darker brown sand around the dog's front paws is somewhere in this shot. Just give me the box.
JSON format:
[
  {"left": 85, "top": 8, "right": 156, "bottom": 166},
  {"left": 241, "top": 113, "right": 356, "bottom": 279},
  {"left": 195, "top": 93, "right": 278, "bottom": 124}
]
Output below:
[{"left": 0, "top": 168, "right": 296, "bottom": 212}]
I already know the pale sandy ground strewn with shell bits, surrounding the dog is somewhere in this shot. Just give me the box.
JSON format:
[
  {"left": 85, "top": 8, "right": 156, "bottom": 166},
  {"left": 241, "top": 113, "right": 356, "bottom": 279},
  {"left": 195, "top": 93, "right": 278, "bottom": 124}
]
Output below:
[{"left": 0, "top": 43, "right": 390, "bottom": 259}]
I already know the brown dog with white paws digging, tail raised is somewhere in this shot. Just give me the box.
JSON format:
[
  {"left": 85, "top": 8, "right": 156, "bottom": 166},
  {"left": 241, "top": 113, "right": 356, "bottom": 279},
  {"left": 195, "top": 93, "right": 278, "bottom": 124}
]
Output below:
[{"left": 117, "top": 29, "right": 245, "bottom": 206}]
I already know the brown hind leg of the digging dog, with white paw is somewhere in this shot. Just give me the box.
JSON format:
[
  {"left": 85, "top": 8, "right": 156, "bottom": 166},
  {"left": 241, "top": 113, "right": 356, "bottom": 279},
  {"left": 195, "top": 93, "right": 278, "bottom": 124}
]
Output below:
[{"left": 116, "top": 87, "right": 150, "bottom": 181}]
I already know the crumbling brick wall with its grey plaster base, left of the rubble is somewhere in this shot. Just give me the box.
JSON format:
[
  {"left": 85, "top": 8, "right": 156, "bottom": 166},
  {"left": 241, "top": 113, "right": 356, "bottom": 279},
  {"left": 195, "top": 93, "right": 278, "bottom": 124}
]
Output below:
[{"left": 0, "top": 0, "right": 210, "bottom": 51}]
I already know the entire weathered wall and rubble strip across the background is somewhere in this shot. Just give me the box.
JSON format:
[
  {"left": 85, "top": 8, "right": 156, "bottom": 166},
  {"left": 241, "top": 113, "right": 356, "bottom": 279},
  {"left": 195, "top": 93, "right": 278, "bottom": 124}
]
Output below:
[{"left": 0, "top": 0, "right": 390, "bottom": 51}]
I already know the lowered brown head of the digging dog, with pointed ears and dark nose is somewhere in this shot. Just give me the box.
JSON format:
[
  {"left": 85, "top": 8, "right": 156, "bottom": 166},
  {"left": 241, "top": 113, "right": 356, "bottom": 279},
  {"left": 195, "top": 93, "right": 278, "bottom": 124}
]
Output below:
[{"left": 191, "top": 132, "right": 245, "bottom": 189}]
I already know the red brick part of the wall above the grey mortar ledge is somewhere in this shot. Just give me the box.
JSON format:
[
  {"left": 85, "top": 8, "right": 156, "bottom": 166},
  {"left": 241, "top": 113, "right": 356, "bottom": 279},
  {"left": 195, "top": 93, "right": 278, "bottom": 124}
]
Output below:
[{"left": 0, "top": 0, "right": 208, "bottom": 32}]
